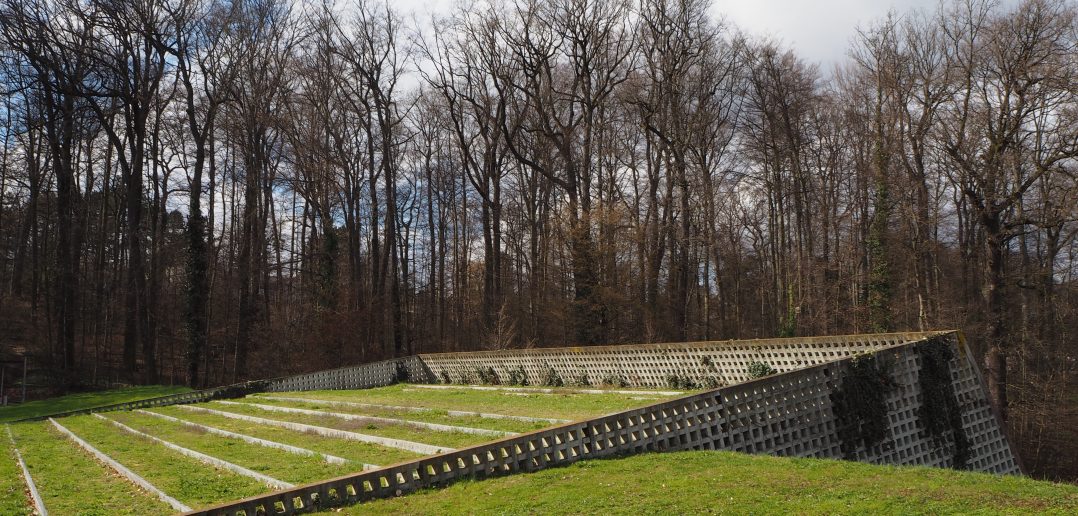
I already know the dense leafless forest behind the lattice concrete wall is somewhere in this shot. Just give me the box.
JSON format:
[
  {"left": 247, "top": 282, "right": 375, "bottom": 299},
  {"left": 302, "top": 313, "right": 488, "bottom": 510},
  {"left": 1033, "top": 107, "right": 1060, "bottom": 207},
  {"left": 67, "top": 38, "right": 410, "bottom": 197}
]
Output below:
[{"left": 0, "top": 0, "right": 1078, "bottom": 477}]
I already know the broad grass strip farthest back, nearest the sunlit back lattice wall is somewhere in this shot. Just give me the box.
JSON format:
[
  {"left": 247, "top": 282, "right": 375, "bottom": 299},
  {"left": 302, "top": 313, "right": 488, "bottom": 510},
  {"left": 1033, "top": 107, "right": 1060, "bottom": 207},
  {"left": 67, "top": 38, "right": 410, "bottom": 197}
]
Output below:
[{"left": 250, "top": 383, "right": 674, "bottom": 420}]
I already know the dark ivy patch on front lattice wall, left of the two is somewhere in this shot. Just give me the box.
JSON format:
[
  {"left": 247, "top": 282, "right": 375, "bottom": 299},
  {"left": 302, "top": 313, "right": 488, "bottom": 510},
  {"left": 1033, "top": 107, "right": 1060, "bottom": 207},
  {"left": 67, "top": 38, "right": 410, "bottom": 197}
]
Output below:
[{"left": 830, "top": 354, "right": 895, "bottom": 460}]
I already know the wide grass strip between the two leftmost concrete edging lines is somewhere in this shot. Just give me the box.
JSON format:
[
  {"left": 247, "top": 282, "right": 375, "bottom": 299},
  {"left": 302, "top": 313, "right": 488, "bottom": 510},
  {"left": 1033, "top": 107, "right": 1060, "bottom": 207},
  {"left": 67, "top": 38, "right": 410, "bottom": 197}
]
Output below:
[{"left": 7, "top": 421, "right": 172, "bottom": 516}]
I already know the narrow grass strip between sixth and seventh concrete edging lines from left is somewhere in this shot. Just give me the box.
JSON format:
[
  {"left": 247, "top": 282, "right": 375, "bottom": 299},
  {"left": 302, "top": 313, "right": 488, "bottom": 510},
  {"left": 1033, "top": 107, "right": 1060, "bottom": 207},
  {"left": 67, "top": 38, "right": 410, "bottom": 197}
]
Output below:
[{"left": 236, "top": 398, "right": 553, "bottom": 433}]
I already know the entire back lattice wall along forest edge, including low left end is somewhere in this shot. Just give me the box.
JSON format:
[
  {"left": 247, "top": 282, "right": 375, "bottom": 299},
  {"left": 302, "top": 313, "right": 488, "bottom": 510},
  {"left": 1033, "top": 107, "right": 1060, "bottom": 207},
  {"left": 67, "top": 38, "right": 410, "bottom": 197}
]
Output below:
[{"left": 14, "top": 332, "right": 953, "bottom": 422}]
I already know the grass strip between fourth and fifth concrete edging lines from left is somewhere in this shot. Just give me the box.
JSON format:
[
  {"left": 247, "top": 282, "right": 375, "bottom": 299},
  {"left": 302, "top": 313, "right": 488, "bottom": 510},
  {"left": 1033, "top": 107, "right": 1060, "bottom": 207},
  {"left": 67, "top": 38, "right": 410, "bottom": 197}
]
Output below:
[{"left": 153, "top": 407, "right": 423, "bottom": 465}]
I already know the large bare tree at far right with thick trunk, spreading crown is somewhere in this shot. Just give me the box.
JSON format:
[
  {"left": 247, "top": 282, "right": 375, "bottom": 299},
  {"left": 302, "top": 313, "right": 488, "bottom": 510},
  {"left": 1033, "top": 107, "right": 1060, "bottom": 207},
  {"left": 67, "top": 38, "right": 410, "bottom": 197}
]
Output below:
[{"left": 940, "top": 0, "right": 1078, "bottom": 417}]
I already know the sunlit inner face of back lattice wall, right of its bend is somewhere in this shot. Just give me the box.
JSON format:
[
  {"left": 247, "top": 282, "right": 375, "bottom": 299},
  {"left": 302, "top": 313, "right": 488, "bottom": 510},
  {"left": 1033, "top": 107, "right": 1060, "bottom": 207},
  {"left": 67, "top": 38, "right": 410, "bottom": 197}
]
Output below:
[{"left": 420, "top": 333, "right": 935, "bottom": 388}]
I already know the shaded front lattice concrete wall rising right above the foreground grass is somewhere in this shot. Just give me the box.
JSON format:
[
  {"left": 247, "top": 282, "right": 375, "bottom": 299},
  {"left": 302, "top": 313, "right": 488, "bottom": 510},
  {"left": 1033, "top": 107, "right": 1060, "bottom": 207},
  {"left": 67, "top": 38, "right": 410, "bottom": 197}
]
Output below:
[{"left": 189, "top": 333, "right": 1019, "bottom": 515}]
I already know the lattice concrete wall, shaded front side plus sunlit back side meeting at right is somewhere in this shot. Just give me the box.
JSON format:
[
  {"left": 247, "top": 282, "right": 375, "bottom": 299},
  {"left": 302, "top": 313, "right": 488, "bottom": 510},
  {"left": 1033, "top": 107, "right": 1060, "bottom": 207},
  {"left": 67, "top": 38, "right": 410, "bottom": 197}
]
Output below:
[{"left": 189, "top": 332, "right": 1020, "bottom": 515}]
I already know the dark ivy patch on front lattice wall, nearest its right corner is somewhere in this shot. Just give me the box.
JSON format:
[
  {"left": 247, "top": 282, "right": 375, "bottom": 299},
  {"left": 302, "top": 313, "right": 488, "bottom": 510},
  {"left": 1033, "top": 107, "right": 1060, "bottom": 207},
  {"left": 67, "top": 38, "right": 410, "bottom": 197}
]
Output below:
[{"left": 917, "top": 340, "right": 970, "bottom": 470}]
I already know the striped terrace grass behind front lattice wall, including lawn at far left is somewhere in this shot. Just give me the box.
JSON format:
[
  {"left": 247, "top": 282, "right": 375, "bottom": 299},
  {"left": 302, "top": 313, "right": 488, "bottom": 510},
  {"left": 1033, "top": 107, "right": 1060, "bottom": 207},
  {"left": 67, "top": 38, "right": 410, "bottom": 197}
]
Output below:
[{"left": 0, "top": 386, "right": 662, "bottom": 515}]
